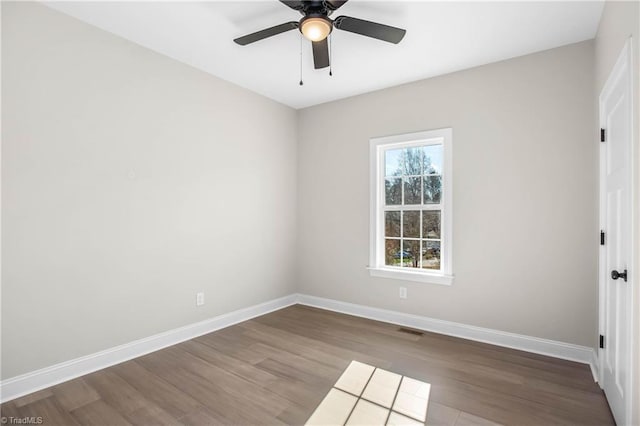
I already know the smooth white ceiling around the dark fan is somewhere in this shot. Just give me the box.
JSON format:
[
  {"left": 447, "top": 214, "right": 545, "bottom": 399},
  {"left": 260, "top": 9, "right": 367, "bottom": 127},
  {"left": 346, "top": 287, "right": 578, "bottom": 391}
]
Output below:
[{"left": 45, "top": 0, "right": 604, "bottom": 108}]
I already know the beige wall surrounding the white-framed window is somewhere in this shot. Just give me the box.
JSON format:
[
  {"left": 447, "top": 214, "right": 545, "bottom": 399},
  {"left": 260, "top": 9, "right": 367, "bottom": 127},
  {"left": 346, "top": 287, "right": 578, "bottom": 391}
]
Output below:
[{"left": 298, "top": 41, "right": 598, "bottom": 346}]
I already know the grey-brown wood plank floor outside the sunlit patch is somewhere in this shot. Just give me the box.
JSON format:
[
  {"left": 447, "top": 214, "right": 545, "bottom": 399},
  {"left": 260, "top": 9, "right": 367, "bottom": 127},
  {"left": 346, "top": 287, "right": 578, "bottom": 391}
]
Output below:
[{"left": 1, "top": 305, "right": 614, "bottom": 425}]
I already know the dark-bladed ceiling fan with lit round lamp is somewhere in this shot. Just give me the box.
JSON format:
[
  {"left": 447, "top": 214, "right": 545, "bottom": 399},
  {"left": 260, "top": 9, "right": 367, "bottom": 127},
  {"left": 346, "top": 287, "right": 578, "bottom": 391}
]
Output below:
[{"left": 233, "top": 0, "right": 406, "bottom": 69}]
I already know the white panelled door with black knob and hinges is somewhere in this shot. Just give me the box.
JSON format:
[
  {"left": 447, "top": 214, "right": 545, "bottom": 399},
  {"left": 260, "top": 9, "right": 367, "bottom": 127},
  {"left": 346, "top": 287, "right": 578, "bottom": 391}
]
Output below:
[{"left": 599, "top": 40, "right": 633, "bottom": 425}]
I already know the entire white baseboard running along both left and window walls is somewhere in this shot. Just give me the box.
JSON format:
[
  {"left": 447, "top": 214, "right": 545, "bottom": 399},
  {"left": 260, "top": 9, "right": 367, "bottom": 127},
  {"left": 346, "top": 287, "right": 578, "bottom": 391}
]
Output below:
[{"left": 0, "top": 294, "right": 598, "bottom": 403}]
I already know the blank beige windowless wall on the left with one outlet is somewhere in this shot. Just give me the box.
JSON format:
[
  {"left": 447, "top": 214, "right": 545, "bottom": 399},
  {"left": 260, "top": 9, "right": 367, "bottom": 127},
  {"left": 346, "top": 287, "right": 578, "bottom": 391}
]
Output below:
[{"left": 2, "top": 2, "right": 297, "bottom": 378}]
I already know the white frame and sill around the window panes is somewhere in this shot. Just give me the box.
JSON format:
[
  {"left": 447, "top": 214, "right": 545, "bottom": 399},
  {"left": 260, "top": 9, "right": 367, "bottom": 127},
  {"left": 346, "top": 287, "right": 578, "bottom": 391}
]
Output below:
[{"left": 368, "top": 128, "right": 454, "bottom": 285}]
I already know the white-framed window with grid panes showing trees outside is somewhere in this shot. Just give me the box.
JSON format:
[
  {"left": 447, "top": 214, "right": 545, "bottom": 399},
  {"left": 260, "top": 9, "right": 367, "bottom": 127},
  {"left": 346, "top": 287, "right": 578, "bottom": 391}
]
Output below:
[{"left": 369, "top": 129, "right": 453, "bottom": 284}]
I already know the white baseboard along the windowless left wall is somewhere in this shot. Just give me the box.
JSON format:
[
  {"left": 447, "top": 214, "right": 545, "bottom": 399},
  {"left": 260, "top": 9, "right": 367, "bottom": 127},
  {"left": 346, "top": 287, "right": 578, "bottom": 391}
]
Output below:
[{"left": 0, "top": 294, "right": 297, "bottom": 402}]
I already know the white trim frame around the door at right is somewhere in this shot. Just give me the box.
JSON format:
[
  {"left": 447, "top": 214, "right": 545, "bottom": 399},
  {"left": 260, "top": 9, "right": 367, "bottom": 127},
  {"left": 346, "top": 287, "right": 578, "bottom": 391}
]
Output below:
[{"left": 596, "top": 37, "right": 639, "bottom": 423}]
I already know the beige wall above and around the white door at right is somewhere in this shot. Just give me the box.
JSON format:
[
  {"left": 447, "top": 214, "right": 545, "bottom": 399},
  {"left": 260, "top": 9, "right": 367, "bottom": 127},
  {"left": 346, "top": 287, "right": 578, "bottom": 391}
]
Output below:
[{"left": 595, "top": 1, "right": 640, "bottom": 425}]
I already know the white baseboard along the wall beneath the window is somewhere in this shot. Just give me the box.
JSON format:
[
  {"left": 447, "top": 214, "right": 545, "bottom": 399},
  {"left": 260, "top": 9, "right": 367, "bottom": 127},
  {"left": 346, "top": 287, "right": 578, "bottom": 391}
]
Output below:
[{"left": 298, "top": 294, "right": 598, "bottom": 381}]
